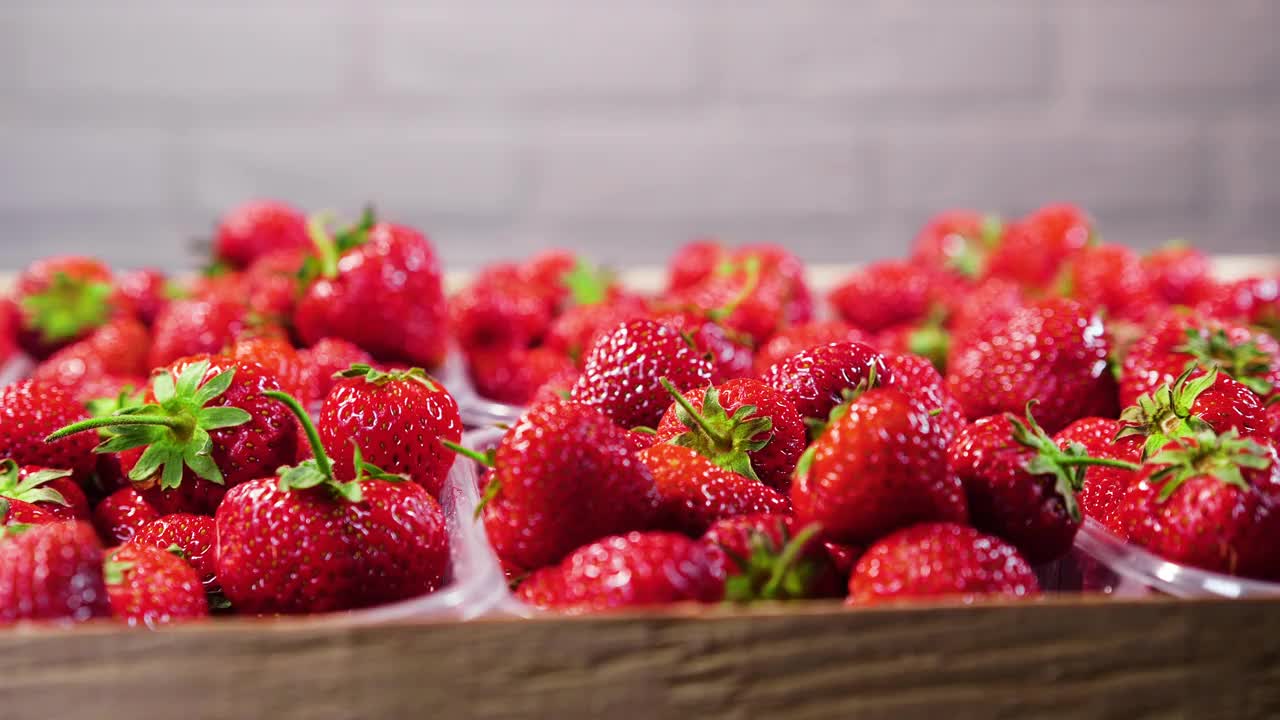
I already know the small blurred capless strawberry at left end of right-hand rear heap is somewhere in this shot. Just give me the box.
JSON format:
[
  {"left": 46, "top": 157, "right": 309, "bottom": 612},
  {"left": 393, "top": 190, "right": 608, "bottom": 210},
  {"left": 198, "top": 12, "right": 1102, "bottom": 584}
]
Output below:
[{"left": 828, "top": 260, "right": 941, "bottom": 333}]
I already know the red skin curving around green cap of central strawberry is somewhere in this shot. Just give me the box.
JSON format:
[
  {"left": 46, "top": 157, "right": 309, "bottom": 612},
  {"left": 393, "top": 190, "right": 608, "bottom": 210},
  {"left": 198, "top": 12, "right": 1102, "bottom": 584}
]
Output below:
[{"left": 655, "top": 378, "right": 806, "bottom": 492}]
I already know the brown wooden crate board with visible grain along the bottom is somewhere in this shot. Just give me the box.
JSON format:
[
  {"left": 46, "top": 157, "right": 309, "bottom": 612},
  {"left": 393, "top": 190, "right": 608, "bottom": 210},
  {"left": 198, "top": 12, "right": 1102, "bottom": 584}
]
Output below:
[{"left": 0, "top": 597, "right": 1280, "bottom": 720}]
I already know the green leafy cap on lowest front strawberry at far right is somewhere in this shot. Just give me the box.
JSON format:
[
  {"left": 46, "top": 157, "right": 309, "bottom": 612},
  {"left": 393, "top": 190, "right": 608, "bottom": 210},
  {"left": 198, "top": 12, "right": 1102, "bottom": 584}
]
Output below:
[{"left": 1147, "top": 429, "right": 1271, "bottom": 502}]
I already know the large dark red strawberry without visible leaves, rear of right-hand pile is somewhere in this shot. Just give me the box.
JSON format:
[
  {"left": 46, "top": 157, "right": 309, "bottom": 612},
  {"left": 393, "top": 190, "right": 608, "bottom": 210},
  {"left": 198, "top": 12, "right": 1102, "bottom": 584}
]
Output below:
[{"left": 947, "top": 299, "right": 1116, "bottom": 433}]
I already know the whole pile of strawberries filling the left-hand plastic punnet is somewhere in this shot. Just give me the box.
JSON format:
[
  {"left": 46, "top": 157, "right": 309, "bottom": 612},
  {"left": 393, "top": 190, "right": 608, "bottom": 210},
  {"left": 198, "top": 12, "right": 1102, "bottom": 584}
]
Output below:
[{"left": 0, "top": 202, "right": 462, "bottom": 625}]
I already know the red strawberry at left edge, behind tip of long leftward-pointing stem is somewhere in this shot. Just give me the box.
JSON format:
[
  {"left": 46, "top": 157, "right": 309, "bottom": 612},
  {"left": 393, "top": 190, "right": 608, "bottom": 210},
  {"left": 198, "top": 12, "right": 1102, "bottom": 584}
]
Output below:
[{"left": 0, "top": 379, "right": 97, "bottom": 480}]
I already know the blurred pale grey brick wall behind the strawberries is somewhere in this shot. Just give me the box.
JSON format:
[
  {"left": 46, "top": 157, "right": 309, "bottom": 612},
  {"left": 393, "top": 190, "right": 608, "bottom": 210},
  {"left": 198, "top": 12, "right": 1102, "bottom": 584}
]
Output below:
[{"left": 0, "top": 0, "right": 1280, "bottom": 268}]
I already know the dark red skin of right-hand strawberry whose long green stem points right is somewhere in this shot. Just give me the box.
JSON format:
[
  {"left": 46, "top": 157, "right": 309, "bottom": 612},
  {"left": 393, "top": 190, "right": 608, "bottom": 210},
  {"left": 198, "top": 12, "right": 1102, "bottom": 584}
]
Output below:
[{"left": 947, "top": 415, "right": 1080, "bottom": 565}]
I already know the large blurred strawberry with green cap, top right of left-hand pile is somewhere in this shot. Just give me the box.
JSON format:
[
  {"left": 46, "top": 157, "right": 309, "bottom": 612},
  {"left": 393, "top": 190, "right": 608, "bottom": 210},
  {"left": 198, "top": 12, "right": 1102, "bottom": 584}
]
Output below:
[{"left": 293, "top": 219, "right": 448, "bottom": 368}]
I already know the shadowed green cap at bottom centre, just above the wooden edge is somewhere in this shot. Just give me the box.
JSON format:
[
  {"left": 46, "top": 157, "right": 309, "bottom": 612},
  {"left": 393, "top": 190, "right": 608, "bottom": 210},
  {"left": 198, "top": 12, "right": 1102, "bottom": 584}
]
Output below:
[{"left": 721, "top": 520, "right": 820, "bottom": 603}]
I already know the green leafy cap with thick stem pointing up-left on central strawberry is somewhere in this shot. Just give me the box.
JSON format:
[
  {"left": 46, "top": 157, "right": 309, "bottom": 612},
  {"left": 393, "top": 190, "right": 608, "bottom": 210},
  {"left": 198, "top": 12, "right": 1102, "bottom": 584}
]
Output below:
[{"left": 658, "top": 378, "right": 773, "bottom": 480}]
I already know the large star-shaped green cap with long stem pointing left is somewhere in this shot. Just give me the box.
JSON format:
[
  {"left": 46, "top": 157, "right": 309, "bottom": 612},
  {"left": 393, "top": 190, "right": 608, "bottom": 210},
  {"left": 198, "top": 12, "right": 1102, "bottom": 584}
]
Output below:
[{"left": 45, "top": 360, "right": 252, "bottom": 489}]
